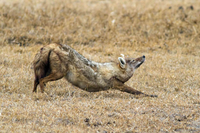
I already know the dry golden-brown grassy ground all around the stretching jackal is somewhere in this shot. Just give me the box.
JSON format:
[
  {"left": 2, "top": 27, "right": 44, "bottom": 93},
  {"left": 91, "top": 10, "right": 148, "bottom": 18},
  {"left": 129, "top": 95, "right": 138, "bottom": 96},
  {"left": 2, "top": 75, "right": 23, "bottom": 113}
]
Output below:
[{"left": 0, "top": 0, "right": 200, "bottom": 133}]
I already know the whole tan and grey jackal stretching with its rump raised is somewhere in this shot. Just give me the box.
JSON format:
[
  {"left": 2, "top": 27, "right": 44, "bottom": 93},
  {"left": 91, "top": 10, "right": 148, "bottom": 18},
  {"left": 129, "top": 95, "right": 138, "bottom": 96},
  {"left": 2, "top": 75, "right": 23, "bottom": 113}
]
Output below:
[{"left": 33, "top": 43, "right": 155, "bottom": 97}]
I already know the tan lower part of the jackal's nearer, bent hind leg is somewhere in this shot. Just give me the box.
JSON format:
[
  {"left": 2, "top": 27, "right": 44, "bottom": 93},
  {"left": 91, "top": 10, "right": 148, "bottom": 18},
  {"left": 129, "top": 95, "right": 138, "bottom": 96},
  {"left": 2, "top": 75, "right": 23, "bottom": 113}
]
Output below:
[{"left": 40, "top": 72, "right": 64, "bottom": 93}]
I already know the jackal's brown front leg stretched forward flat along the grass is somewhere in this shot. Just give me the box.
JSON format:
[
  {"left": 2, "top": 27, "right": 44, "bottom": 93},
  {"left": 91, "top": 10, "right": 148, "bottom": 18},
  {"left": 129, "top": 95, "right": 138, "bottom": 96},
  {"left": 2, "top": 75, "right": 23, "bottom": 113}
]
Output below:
[{"left": 114, "top": 83, "right": 157, "bottom": 97}]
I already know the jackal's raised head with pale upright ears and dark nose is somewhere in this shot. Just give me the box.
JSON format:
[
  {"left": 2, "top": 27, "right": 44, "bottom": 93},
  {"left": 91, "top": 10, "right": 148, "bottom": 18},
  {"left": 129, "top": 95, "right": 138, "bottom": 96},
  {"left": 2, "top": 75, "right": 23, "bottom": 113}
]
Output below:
[{"left": 116, "top": 55, "right": 145, "bottom": 83}]
